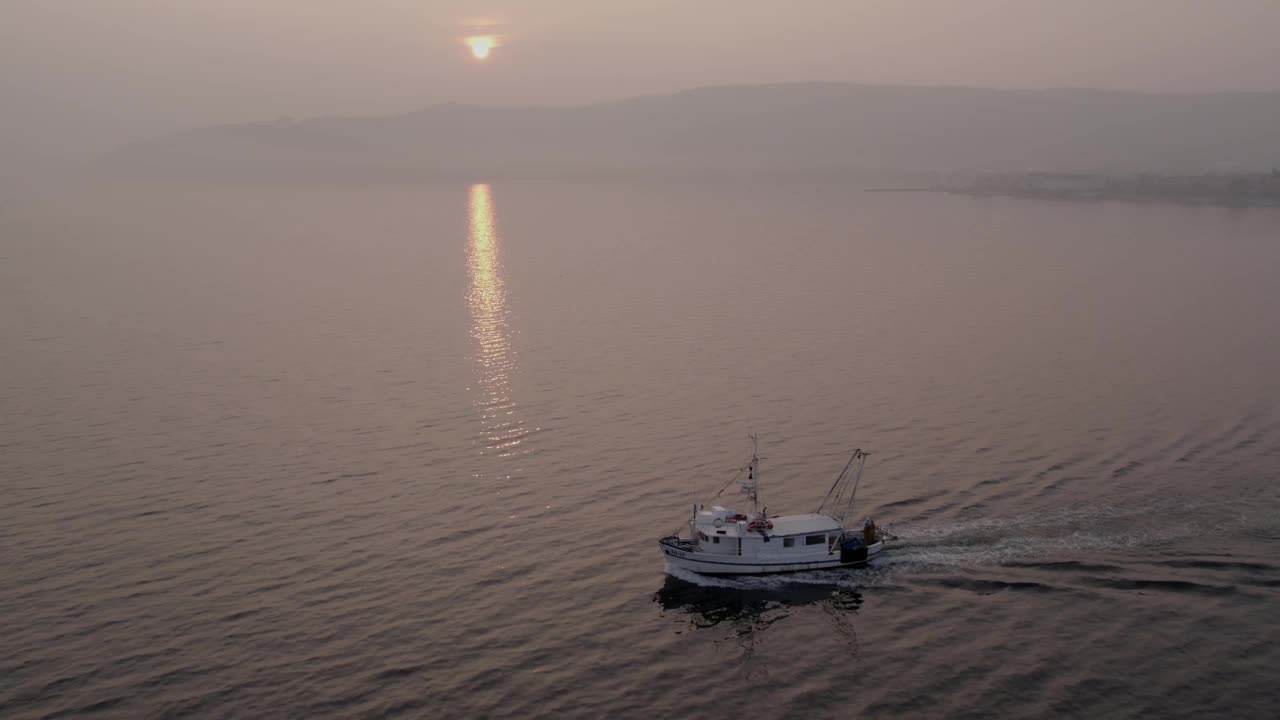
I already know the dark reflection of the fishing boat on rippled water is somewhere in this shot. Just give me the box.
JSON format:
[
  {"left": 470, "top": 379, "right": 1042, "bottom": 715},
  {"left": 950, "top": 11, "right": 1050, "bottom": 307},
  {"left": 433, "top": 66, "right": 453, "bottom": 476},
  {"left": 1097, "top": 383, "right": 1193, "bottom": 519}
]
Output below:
[{"left": 653, "top": 574, "right": 863, "bottom": 656}]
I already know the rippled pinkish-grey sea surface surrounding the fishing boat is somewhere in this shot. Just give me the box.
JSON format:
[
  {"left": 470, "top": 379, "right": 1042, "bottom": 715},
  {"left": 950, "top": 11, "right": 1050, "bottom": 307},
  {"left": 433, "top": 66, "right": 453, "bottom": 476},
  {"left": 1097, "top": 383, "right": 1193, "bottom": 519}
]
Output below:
[{"left": 0, "top": 182, "right": 1280, "bottom": 717}]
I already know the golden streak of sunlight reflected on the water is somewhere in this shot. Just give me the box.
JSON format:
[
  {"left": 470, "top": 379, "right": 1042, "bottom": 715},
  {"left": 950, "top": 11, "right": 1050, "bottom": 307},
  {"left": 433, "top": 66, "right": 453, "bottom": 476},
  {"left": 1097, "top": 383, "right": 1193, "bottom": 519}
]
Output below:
[{"left": 467, "top": 184, "right": 527, "bottom": 456}]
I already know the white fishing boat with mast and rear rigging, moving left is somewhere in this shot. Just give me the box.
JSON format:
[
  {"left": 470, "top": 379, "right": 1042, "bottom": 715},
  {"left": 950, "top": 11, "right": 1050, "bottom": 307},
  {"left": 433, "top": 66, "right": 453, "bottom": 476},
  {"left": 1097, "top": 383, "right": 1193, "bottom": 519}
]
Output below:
[{"left": 658, "top": 434, "right": 895, "bottom": 575}]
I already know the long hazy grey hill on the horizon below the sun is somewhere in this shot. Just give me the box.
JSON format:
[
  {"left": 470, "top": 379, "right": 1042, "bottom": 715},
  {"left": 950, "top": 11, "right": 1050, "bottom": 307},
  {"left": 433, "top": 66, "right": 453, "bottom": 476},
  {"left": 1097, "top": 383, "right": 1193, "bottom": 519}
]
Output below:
[{"left": 105, "top": 83, "right": 1280, "bottom": 181}]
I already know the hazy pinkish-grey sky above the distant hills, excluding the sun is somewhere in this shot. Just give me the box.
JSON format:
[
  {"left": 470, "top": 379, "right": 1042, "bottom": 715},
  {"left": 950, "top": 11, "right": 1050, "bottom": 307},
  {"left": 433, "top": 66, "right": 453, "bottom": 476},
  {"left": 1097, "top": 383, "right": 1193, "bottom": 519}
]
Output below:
[{"left": 0, "top": 0, "right": 1280, "bottom": 161}]
